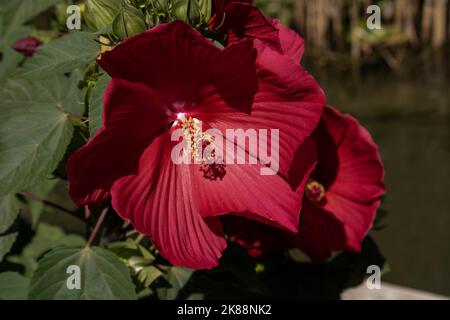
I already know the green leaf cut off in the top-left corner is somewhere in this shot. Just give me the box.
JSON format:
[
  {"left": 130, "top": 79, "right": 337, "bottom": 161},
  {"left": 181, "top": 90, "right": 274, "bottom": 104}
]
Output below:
[{"left": 0, "top": 0, "right": 62, "bottom": 46}]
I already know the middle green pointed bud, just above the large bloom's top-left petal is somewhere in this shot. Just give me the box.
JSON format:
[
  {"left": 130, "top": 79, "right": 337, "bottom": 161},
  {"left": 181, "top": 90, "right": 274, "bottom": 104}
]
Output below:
[{"left": 113, "top": 4, "right": 147, "bottom": 40}]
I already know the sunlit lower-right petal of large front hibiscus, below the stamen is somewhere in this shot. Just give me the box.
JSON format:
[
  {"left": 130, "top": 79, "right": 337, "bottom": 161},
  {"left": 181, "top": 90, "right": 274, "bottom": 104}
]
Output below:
[{"left": 191, "top": 164, "right": 302, "bottom": 232}]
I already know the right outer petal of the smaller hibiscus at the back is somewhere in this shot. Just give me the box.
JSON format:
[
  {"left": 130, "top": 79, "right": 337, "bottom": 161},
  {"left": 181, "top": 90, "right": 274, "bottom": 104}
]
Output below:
[{"left": 313, "top": 107, "right": 385, "bottom": 251}]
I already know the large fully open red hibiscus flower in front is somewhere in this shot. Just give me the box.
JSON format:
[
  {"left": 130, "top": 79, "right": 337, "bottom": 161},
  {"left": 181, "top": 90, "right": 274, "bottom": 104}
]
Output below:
[{"left": 67, "top": 21, "right": 324, "bottom": 269}]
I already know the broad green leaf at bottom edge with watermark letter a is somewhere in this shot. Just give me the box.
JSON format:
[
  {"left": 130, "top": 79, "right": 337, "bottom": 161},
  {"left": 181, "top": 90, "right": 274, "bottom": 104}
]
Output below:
[{"left": 29, "top": 247, "right": 136, "bottom": 300}]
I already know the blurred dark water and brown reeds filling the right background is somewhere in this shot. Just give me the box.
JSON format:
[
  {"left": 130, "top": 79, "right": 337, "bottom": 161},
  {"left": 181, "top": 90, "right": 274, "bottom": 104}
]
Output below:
[{"left": 256, "top": 0, "right": 450, "bottom": 295}]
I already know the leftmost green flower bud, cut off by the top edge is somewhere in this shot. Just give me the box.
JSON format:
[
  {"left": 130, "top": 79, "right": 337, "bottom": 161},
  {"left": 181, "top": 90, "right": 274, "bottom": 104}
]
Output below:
[{"left": 84, "top": 0, "right": 121, "bottom": 32}]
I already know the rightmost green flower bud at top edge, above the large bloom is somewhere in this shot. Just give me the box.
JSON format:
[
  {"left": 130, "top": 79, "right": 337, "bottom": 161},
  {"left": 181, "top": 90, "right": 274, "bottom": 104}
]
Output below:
[{"left": 173, "top": 0, "right": 212, "bottom": 27}]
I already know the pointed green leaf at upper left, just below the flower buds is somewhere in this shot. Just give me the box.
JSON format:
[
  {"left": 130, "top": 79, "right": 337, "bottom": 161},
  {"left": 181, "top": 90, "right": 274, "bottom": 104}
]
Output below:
[{"left": 15, "top": 31, "right": 100, "bottom": 80}]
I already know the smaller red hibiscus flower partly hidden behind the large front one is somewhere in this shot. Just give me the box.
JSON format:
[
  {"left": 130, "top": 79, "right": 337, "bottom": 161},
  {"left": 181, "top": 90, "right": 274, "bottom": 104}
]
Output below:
[{"left": 222, "top": 107, "right": 385, "bottom": 260}]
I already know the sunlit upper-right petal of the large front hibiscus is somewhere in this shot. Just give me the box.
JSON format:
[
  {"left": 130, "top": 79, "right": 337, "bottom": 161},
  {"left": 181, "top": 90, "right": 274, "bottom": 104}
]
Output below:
[{"left": 193, "top": 40, "right": 325, "bottom": 185}]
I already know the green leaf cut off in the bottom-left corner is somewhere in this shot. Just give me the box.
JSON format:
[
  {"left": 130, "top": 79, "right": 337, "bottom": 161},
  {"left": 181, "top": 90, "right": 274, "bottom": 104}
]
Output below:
[{"left": 0, "top": 272, "right": 30, "bottom": 300}]
